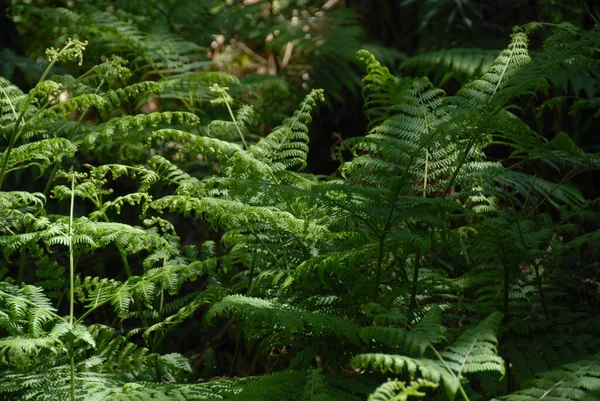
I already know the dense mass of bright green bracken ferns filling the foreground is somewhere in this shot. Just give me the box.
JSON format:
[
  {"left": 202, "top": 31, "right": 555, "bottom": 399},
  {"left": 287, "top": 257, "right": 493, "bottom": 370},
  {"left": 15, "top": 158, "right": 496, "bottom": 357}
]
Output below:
[{"left": 0, "top": 15, "right": 600, "bottom": 401}]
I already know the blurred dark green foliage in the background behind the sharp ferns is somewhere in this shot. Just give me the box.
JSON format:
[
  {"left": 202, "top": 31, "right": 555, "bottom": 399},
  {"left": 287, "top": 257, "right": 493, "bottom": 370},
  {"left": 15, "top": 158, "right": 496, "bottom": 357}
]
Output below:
[{"left": 0, "top": 0, "right": 600, "bottom": 174}]
